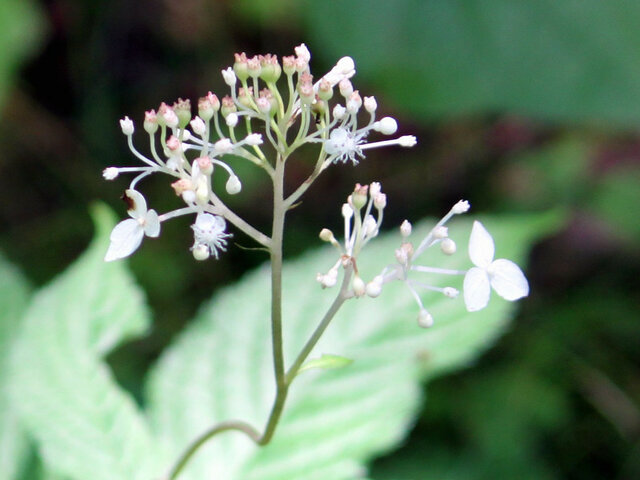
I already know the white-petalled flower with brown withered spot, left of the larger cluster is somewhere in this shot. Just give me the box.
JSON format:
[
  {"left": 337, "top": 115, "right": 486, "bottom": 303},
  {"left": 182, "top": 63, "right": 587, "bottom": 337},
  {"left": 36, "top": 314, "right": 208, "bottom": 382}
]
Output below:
[{"left": 104, "top": 190, "right": 160, "bottom": 262}]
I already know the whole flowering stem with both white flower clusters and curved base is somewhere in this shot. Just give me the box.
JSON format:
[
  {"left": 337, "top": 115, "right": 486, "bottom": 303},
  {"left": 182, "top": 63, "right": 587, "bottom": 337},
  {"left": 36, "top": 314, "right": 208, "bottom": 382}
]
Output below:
[{"left": 104, "top": 44, "right": 529, "bottom": 479}]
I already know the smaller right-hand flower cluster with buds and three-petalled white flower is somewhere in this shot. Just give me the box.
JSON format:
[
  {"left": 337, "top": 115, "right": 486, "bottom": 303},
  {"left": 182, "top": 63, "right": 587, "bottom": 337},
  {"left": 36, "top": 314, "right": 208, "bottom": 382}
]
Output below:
[{"left": 317, "top": 182, "right": 529, "bottom": 327}]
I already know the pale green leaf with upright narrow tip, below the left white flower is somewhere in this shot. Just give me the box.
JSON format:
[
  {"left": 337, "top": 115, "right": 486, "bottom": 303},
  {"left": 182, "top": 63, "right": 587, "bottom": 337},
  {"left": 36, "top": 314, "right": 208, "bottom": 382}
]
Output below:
[{"left": 11, "top": 207, "right": 158, "bottom": 480}]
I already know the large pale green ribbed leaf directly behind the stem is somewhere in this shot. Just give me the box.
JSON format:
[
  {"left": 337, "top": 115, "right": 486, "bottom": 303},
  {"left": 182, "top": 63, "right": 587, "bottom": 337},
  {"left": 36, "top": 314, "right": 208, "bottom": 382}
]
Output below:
[{"left": 148, "top": 214, "right": 561, "bottom": 480}]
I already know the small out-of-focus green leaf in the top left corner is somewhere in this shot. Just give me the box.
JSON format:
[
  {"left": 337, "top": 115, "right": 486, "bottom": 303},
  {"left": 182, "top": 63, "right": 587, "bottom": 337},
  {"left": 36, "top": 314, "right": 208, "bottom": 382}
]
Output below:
[{"left": 0, "top": 0, "right": 45, "bottom": 109}]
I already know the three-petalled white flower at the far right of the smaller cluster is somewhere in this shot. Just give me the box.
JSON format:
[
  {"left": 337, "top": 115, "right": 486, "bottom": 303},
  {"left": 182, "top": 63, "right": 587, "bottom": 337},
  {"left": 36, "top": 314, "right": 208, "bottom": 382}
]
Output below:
[{"left": 464, "top": 221, "right": 529, "bottom": 312}]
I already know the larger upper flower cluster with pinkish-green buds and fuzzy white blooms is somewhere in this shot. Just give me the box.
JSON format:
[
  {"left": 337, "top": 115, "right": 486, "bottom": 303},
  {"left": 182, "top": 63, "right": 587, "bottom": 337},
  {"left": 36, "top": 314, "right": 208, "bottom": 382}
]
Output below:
[{"left": 103, "top": 44, "right": 416, "bottom": 261}]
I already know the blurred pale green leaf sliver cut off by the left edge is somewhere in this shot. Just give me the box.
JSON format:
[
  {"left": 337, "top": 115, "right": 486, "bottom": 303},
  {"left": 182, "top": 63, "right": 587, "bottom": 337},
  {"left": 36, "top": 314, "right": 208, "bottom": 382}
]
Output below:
[{"left": 0, "top": 255, "right": 29, "bottom": 479}]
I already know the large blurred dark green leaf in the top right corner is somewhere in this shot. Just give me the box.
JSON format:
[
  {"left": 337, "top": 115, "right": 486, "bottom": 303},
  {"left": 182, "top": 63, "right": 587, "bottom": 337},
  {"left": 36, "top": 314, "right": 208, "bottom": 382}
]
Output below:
[{"left": 300, "top": 0, "right": 640, "bottom": 127}]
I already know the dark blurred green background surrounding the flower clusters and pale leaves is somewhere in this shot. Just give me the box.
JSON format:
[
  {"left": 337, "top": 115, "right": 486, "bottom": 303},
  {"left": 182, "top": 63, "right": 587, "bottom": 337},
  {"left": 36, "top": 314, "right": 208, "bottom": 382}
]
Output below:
[{"left": 0, "top": 0, "right": 640, "bottom": 480}]
